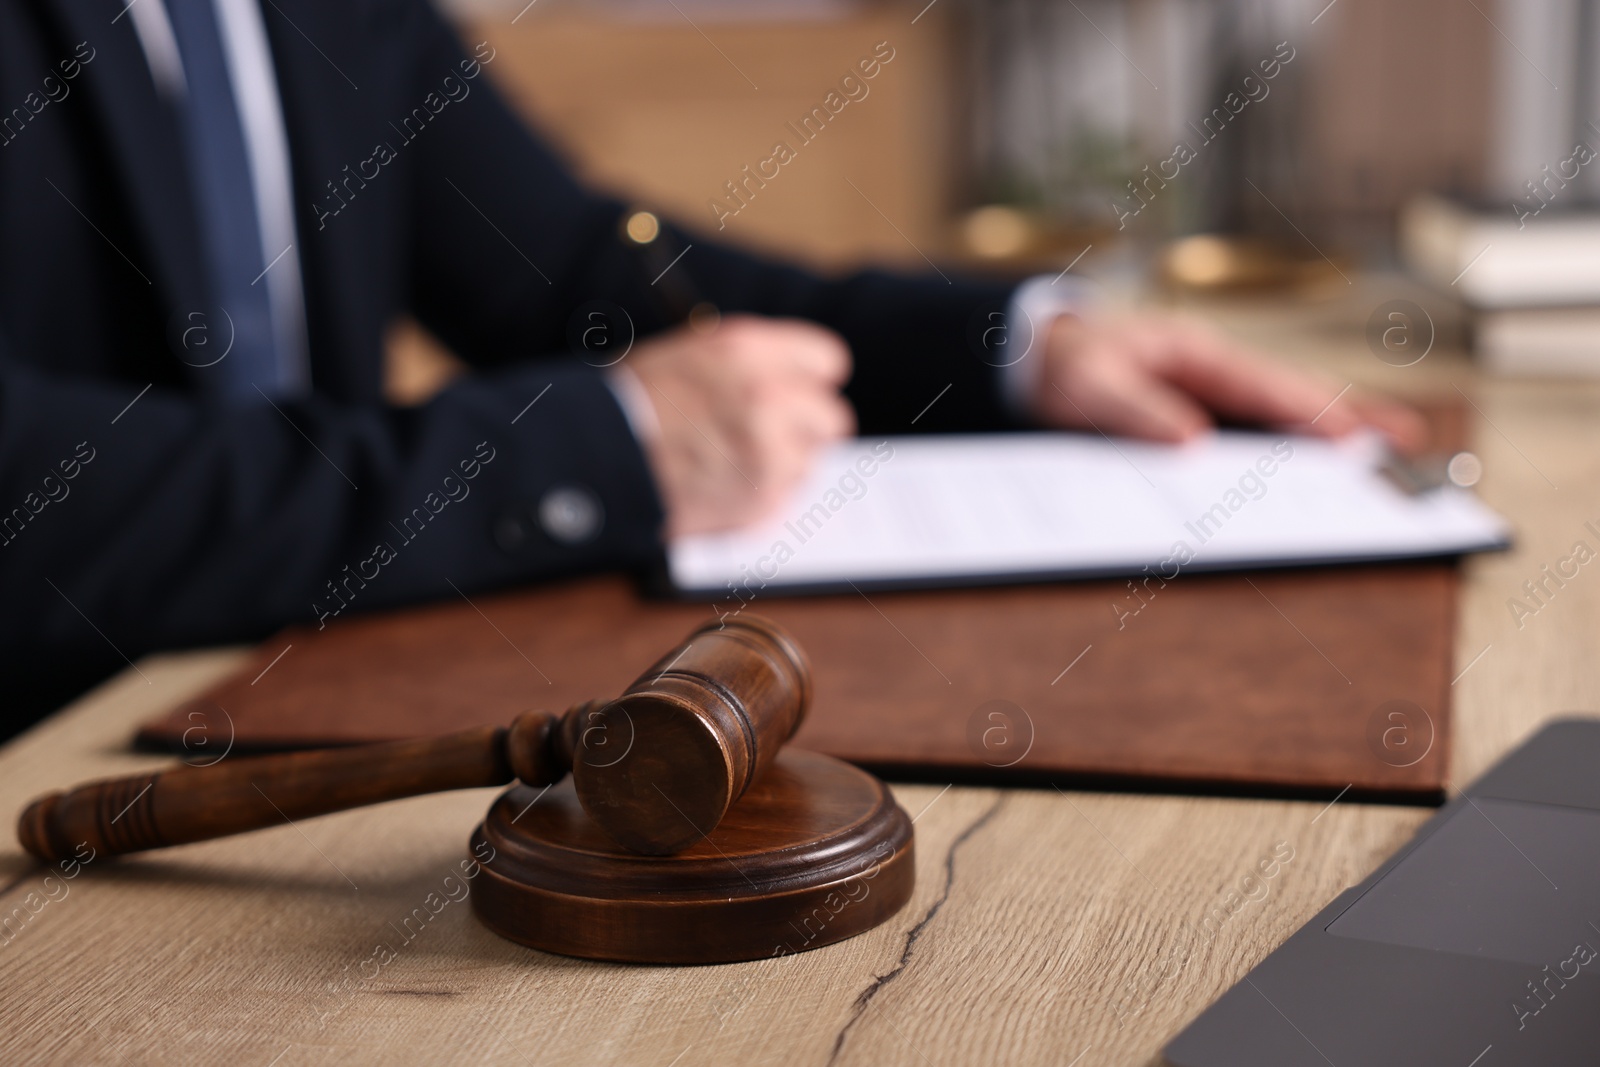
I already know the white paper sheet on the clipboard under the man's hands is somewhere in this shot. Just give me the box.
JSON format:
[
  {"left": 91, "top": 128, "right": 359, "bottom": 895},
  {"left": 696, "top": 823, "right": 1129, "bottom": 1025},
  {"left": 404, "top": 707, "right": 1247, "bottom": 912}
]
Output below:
[{"left": 667, "top": 432, "right": 1509, "bottom": 598}]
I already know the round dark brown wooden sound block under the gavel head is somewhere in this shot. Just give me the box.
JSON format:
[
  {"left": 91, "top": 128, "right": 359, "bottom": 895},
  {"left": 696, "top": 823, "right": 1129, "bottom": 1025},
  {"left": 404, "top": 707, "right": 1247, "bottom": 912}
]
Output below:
[{"left": 472, "top": 749, "right": 917, "bottom": 963}]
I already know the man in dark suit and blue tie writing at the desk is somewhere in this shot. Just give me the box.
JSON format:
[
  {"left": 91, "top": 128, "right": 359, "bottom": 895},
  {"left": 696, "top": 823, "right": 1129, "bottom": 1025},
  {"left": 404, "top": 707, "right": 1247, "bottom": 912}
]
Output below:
[{"left": 0, "top": 0, "right": 1410, "bottom": 729}]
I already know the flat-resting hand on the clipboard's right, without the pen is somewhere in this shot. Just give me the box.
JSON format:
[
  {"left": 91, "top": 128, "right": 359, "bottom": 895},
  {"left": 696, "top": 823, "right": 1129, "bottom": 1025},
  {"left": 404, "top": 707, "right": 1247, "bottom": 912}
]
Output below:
[{"left": 1029, "top": 315, "right": 1427, "bottom": 451}]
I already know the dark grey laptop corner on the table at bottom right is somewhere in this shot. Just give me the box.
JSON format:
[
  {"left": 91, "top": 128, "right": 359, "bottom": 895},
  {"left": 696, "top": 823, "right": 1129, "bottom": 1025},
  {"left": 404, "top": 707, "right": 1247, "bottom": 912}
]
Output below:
[{"left": 1165, "top": 718, "right": 1600, "bottom": 1067}]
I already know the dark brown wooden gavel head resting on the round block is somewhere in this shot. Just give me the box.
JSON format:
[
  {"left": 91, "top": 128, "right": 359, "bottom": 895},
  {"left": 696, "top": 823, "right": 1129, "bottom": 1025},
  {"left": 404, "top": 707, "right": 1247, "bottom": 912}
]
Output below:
[{"left": 555, "top": 616, "right": 811, "bottom": 856}]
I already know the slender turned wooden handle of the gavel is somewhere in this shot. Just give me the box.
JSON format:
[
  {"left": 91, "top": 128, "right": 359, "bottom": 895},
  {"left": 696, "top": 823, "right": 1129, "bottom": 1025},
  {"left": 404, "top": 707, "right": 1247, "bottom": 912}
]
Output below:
[{"left": 18, "top": 712, "right": 566, "bottom": 864}]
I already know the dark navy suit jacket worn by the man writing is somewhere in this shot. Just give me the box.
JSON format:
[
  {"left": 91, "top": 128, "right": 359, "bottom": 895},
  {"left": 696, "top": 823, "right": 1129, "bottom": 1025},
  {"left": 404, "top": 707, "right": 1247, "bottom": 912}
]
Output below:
[{"left": 0, "top": 0, "right": 1010, "bottom": 726}]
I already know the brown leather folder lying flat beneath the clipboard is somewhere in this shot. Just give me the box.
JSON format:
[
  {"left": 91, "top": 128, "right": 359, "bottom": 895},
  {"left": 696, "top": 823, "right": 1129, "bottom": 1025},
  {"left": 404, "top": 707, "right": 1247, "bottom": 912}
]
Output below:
[{"left": 139, "top": 405, "right": 1462, "bottom": 801}]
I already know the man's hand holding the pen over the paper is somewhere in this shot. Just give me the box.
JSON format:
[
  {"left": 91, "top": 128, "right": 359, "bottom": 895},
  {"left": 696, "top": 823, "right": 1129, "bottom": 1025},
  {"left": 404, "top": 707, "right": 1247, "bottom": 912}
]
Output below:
[{"left": 627, "top": 315, "right": 856, "bottom": 537}]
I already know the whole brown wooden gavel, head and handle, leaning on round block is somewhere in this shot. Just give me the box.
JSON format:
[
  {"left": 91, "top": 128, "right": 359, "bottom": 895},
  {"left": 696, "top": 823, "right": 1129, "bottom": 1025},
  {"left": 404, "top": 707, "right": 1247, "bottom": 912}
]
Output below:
[{"left": 18, "top": 616, "right": 811, "bottom": 862}]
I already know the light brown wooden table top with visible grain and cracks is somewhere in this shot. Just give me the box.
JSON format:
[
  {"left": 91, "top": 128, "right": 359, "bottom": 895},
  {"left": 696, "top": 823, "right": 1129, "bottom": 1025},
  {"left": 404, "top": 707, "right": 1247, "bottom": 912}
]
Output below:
[{"left": 0, "top": 280, "right": 1600, "bottom": 1067}]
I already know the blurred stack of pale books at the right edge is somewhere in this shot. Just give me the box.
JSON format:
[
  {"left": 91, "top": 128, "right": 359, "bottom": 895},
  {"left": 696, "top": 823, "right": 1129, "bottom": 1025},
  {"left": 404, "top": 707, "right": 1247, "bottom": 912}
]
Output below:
[{"left": 1400, "top": 197, "right": 1600, "bottom": 378}]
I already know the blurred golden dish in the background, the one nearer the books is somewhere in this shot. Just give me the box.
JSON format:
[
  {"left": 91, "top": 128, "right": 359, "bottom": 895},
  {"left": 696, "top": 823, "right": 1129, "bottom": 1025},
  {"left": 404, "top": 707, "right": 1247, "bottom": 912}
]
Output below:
[{"left": 1157, "top": 234, "right": 1347, "bottom": 293}]
